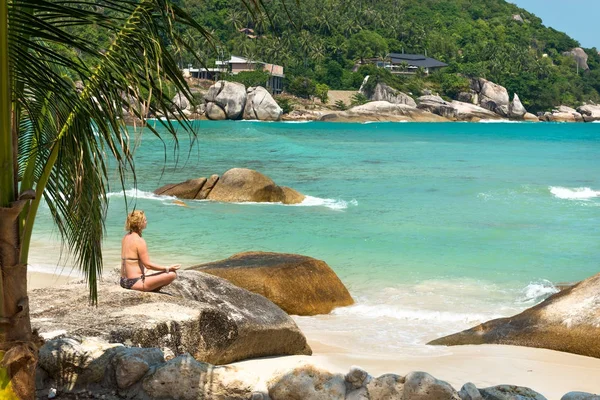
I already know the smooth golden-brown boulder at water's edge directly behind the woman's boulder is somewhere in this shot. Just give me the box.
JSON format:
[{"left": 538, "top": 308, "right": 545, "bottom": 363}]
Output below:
[{"left": 190, "top": 252, "right": 354, "bottom": 315}]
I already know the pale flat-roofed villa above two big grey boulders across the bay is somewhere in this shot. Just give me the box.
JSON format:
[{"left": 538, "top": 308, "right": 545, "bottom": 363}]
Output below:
[{"left": 188, "top": 56, "right": 285, "bottom": 94}]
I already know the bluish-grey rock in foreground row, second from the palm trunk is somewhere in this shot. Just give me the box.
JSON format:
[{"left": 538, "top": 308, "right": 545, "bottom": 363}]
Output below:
[{"left": 111, "top": 347, "right": 165, "bottom": 389}]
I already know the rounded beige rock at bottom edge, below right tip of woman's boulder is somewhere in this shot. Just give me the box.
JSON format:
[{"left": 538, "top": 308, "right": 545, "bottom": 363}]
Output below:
[{"left": 268, "top": 365, "right": 346, "bottom": 400}]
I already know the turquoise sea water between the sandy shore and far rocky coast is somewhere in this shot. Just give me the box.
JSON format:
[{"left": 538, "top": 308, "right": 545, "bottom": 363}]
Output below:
[{"left": 30, "top": 121, "right": 600, "bottom": 356}]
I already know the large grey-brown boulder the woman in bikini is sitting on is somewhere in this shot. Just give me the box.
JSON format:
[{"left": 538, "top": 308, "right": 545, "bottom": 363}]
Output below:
[{"left": 30, "top": 271, "right": 311, "bottom": 364}]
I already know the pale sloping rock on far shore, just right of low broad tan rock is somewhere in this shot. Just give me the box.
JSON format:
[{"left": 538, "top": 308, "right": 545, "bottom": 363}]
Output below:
[{"left": 418, "top": 96, "right": 500, "bottom": 121}]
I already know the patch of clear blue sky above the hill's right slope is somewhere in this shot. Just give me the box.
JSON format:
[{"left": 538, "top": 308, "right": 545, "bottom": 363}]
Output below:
[{"left": 508, "top": 0, "right": 600, "bottom": 50}]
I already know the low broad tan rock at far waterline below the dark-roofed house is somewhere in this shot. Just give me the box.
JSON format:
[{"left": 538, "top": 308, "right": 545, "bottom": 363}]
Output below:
[{"left": 320, "top": 101, "right": 447, "bottom": 122}]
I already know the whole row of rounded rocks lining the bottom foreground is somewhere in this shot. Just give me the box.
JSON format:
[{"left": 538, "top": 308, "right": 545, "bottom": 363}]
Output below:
[{"left": 36, "top": 339, "right": 556, "bottom": 400}]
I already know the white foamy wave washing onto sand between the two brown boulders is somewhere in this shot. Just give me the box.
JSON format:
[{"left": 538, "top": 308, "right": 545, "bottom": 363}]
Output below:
[{"left": 332, "top": 304, "right": 503, "bottom": 324}]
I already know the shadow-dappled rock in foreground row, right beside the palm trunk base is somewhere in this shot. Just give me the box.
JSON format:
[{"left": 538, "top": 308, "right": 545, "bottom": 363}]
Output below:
[{"left": 34, "top": 338, "right": 122, "bottom": 390}]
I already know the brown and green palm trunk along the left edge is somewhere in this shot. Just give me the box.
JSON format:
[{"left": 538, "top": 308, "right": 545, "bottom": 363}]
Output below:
[{"left": 0, "top": 0, "right": 37, "bottom": 400}]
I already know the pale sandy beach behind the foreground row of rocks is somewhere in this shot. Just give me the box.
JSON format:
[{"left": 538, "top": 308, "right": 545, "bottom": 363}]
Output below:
[{"left": 28, "top": 272, "right": 600, "bottom": 399}]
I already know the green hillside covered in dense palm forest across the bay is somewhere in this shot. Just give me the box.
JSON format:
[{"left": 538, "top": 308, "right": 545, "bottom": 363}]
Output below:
[{"left": 86, "top": 0, "right": 600, "bottom": 111}]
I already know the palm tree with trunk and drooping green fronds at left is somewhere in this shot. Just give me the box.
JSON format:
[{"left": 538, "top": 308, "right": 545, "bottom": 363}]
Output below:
[{"left": 0, "top": 0, "right": 257, "bottom": 399}]
